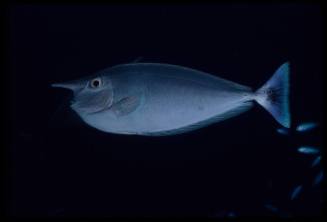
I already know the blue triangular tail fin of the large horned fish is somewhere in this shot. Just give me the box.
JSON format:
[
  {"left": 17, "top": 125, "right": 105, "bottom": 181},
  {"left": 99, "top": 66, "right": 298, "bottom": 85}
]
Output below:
[{"left": 255, "top": 62, "right": 291, "bottom": 128}]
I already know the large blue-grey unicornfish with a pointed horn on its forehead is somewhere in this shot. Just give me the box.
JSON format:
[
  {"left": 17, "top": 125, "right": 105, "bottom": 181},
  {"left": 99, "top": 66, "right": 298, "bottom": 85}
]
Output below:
[{"left": 53, "top": 63, "right": 290, "bottom": 136}]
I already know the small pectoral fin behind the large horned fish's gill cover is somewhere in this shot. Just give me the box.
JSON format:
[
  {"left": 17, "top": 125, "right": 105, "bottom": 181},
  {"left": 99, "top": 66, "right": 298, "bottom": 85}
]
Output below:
[{"left": 111, "top": 96, "right": 141, "bottom": 116}]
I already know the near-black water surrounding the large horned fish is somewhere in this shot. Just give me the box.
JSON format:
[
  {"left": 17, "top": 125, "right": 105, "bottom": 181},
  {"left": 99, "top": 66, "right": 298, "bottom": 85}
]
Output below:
[{"left": 6, "top": 4, "right": 323, "bottom": 217}]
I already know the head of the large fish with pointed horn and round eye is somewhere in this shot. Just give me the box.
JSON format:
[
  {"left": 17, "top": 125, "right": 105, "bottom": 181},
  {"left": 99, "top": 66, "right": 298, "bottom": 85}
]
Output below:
[{"left": 51, "top": 75, "right": 113, "bottom": 115}]
